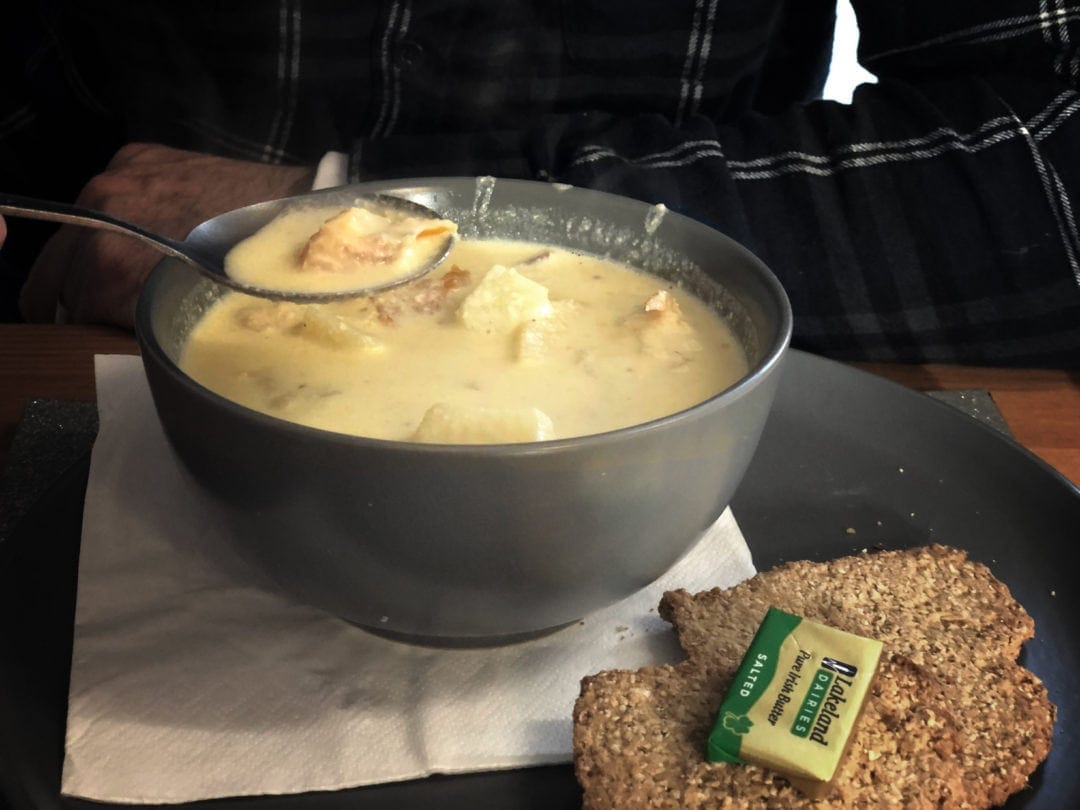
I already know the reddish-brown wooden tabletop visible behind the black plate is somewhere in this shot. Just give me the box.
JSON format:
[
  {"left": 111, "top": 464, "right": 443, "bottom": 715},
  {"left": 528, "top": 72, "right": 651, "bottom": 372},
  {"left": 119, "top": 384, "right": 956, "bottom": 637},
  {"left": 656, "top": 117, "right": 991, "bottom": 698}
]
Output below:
[{"left": 6, "top": 324, "right": 1080, "bottom": 484}]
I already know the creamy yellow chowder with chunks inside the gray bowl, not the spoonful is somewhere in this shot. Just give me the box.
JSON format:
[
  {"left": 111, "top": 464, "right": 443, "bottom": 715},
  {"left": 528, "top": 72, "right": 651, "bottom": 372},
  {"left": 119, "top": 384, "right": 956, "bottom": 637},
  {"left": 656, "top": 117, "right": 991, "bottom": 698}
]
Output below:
[{"left": 180, "top": 228, "right": 746, "bottom": 444}]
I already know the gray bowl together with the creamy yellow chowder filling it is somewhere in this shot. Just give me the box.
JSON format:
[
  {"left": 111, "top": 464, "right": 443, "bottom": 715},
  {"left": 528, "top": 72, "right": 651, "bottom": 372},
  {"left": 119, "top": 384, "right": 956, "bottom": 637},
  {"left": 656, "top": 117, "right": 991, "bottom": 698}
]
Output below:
[{"left": 136, "top": 177, "right": 792, "bottom": 643}]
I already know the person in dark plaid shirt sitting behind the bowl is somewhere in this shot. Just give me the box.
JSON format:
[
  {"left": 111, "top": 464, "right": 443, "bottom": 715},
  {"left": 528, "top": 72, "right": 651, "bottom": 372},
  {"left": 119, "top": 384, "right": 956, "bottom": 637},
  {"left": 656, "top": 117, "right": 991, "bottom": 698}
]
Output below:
[{"left": 0, "top": 0, "right": 1080, "bottom": 367}]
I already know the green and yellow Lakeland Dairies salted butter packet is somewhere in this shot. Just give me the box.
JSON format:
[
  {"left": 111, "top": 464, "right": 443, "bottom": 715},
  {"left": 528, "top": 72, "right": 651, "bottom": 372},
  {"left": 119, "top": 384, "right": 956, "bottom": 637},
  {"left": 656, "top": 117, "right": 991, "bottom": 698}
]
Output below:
[{"left": 706, "top": 607, "right": 881, "bottom": 796}]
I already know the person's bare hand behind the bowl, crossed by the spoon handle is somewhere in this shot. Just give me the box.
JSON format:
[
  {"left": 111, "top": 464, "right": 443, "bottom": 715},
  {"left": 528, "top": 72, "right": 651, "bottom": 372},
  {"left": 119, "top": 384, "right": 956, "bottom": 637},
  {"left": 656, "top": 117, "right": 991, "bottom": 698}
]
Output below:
[{"left": 19, "top": 144, "right": 314, "bottom": 328}]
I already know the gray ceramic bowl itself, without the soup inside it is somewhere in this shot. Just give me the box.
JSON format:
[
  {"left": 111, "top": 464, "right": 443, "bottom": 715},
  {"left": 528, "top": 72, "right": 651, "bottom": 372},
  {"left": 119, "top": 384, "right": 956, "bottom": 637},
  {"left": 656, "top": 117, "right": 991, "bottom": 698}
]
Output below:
[{"left": 136, "top": 178, "right": 792, "bottom": 643}]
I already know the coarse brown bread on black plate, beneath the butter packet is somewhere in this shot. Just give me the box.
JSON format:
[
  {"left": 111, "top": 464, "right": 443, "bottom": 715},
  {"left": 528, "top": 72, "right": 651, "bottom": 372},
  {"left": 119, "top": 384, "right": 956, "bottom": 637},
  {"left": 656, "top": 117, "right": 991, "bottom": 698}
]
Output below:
[{"left": 573, "top": 544, "right": 1056, "bottom": 810}]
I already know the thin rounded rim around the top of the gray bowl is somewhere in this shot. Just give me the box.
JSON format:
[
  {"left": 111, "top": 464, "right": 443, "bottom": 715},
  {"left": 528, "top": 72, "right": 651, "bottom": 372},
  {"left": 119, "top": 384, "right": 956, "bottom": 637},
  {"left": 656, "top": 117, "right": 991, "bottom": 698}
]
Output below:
[{"left": 135, "top": 176, "right": 794, "bottom": 458}]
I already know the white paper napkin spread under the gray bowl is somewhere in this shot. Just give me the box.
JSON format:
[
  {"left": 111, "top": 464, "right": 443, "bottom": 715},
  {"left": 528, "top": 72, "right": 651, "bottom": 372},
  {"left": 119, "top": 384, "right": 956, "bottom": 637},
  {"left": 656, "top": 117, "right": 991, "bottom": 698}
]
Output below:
[{"left": 54, "top": 356, "right": 754, "bottom": 804}]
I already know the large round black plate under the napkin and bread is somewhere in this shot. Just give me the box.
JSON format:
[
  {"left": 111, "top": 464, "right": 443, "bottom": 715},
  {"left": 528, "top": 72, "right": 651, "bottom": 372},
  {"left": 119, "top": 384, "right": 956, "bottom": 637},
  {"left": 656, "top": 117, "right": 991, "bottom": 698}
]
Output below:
[{"left": 0, "top": 352, "right": 1080, "bottom": 810}]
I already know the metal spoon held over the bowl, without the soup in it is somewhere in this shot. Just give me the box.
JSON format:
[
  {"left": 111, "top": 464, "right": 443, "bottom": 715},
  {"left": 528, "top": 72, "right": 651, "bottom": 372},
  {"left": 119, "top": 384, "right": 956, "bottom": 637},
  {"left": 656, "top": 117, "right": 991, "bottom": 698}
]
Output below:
[{"left": 0, "top": 188, "right": 455, "bottom": 302}]
